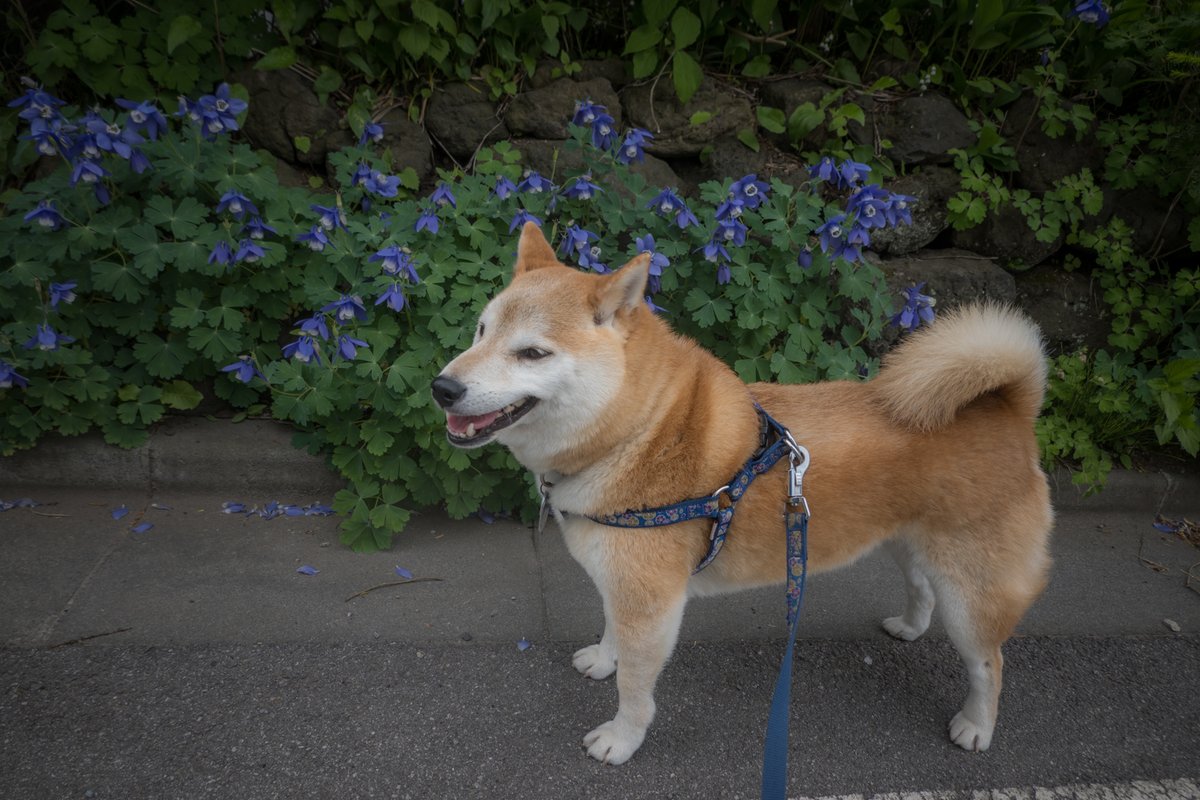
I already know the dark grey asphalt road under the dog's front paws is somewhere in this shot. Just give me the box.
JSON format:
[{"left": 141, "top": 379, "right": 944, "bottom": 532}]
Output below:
[{"left": 0, "top": 636, "right": 1200, "bottom": 800}]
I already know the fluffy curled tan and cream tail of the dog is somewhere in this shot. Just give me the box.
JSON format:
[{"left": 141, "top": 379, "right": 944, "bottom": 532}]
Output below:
[{"left": 874, "top": 303, "right": 1046, "bottom": 431}]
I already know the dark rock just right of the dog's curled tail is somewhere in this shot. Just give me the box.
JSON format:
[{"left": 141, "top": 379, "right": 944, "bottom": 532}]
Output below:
[{"left": 1015, "top": 264, "right": 1112, "bottom": 355}]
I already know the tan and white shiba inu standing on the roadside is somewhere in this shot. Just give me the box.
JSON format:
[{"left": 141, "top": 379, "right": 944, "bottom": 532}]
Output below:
[{"left": 433, "top": 223, "right": 1052, "bottom": 764}]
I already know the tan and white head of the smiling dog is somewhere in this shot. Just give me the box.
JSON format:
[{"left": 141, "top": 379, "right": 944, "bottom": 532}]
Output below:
[{"left": 432, "top": 223, "right": 652, "bottom": 468}]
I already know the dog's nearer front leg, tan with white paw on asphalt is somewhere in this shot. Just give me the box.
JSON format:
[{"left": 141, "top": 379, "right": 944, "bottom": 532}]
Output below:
[{"left": 583, "top": 578, "right": 688, "bottom": 764}]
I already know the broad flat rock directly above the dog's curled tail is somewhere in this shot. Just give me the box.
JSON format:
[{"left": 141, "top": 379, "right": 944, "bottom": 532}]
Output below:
[{"left": 876, "top": 248, "right": 1016, "bottom": 311}]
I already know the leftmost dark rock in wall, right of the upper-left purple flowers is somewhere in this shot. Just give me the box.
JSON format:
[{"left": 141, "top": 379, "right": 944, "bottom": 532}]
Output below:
[{"left": 234, "top": 70, "right": 340, "bottom": 167}]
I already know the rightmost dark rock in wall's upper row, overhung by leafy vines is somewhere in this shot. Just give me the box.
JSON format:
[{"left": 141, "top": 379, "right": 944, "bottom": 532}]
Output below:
[{"left": 1001, "top": 95, "right": 1104, "bottom": 192}]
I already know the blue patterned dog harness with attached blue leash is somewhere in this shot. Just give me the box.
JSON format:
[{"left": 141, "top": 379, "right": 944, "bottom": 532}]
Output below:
[{"left": 539, "top": 403, "right": 809, "bottom": 800}]
